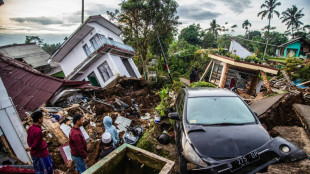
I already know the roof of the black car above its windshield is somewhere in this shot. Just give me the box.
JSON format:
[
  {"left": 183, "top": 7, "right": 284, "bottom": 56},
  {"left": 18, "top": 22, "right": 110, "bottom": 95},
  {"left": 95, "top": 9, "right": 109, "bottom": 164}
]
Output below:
[{"left": 184, "top": 87, "right": 237, "bottom": 97}]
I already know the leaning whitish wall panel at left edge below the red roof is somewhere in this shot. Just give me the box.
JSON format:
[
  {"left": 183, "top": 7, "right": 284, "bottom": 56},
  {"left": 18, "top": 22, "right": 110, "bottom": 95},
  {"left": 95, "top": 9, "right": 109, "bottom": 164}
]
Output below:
[{"left": 0, "top": 78, "right": 32, "bottom": 163}]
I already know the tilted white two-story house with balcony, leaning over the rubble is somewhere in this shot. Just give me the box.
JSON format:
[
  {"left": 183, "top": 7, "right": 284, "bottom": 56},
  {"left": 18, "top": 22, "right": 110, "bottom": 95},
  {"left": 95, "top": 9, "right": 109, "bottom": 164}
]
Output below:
[{"left": 50, "top": 15, "right": 141, "bottom": 87}]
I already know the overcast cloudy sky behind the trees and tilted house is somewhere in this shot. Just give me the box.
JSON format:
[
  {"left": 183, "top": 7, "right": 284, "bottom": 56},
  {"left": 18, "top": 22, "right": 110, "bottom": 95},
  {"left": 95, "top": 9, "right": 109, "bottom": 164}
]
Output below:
[{"left": 0, "top": 0, "right": 310, "bottom": 46}]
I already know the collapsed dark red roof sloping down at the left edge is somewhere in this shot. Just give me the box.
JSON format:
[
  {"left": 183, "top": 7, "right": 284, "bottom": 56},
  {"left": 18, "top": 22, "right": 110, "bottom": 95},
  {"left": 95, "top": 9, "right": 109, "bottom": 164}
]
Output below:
[{"left": 0, "top": 54, "right": 89, "bottom": 118}]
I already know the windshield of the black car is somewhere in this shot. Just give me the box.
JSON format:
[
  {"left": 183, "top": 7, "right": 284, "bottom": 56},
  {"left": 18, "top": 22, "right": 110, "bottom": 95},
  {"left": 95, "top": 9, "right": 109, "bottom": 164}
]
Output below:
[{"left": 187, "top": 97, "right": 255, "bottom": 125}]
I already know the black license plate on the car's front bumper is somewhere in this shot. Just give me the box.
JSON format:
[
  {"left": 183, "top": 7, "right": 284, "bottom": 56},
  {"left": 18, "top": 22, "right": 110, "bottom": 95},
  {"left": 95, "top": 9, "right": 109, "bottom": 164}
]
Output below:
[{"left": 230, "top": 151, "right": 260, "bottom": 172}]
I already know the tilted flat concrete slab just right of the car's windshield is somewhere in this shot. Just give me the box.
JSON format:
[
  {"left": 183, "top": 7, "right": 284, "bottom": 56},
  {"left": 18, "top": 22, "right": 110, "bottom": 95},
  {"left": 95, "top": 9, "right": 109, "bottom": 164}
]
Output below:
[{"left": 250, "top": 94, "right": 284, "bottom": 116}]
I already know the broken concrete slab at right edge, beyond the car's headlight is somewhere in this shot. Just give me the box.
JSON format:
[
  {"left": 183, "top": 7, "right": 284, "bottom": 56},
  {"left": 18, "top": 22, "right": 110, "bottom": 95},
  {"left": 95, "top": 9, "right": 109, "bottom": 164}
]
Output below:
[{"left": 293, "top": 103, "right": 310, "bottom": 135}]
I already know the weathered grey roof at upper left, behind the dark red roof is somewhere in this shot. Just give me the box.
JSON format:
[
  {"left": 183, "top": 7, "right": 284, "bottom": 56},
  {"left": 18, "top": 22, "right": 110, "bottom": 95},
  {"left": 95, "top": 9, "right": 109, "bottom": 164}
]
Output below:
[{"left": 0, "top": 43, "right": 50, "bottom": 68}]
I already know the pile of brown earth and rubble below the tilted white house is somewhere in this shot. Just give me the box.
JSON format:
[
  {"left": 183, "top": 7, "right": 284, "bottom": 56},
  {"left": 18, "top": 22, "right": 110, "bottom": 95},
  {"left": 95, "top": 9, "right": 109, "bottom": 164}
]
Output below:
[{"left": 24, "top": 77, "right": 160, "bottom": 172}]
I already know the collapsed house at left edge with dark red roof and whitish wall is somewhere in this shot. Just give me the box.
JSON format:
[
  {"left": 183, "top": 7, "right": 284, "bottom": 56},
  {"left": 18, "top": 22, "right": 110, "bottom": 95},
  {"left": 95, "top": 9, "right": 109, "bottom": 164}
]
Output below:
[{"left": 0, "top": 54, "right": 91, "bottom": 164}]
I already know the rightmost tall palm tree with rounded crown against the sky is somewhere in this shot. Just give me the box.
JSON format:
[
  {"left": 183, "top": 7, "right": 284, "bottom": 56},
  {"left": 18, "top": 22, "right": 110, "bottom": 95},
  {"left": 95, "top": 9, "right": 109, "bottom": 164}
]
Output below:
[{"left": 281, "top": 5, "right": 305, "bottom": 38}]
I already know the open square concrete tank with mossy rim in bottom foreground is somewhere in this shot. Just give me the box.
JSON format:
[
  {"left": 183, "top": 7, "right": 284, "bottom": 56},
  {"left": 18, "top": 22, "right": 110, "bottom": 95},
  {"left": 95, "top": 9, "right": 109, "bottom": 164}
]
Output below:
[{"left": 84, "top": 144, "right": 175, "bottom": 174}]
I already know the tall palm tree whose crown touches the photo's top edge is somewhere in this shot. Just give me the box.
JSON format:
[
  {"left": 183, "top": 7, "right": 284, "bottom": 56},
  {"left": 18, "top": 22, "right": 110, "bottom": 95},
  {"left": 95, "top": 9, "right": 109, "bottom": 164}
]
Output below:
[{"left": 257, "top": 0, "right": 281, "bottom": 33}]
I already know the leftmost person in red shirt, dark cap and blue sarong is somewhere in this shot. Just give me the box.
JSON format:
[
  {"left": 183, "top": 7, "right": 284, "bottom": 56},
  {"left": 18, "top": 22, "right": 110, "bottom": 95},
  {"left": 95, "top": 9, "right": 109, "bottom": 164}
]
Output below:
[{"left": 26, "top": 111, "right": 53, "bottom": 174}]
